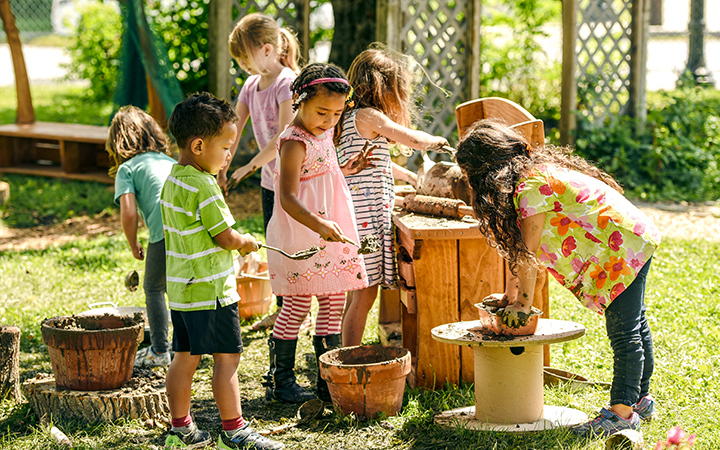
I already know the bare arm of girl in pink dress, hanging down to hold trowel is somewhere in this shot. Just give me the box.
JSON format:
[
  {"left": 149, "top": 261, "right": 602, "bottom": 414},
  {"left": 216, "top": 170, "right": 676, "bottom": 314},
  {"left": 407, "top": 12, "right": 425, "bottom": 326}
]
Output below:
[{"left": 279, "top": 140, "right": 344, "bottom": 242}]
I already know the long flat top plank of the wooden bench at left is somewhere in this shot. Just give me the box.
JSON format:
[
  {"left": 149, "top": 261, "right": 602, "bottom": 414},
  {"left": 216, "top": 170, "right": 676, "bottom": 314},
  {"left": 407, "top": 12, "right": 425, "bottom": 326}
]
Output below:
[{"left": 0, "top": 122, "right": 108, "bottom": 145}]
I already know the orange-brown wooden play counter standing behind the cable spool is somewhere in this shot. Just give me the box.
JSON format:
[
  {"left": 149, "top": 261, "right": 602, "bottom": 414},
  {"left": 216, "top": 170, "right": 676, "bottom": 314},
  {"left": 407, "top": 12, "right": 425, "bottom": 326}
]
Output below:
[{"left": 393, "top": 209, "right": 550, "bottom": 389}]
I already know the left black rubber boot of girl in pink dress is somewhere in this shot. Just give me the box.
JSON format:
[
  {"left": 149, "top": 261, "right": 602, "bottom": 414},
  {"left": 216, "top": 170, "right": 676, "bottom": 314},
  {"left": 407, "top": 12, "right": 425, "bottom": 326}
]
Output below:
[{"left": 263, "top": 337, "right": 317, "bottom": 403}]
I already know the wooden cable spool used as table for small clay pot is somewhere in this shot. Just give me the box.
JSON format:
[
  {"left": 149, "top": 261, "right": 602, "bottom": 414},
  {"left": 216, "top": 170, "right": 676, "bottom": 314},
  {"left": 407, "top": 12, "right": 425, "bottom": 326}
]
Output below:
[{"left": 432, "top": 319, "right": 587, "bottom": 431}]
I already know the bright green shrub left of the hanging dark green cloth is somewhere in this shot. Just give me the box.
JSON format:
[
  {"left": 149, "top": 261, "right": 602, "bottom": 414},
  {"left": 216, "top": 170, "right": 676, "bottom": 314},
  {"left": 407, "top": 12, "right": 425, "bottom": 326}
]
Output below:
[{"left": 66, "top": 2, "right": 122, "bottom": 99}]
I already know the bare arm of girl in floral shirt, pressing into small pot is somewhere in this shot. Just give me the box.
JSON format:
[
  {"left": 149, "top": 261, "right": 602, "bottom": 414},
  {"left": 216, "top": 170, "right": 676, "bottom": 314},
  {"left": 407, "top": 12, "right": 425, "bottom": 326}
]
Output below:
[{"left": 502, "top": 213, "right": 545, "bottom": 327}]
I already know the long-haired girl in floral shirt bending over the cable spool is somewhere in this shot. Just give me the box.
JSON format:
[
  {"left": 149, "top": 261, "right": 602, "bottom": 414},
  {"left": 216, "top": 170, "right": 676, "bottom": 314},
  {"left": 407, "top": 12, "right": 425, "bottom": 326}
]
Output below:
[{"left": 456, "top": 120, "right": 660, "bottom": 436}]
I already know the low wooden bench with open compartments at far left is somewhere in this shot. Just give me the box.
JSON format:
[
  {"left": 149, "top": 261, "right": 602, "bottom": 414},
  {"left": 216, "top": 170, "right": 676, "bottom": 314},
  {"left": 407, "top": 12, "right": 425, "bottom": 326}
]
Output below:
[{"left": 0, "top": 122, "right": 113, "bottom": 184}]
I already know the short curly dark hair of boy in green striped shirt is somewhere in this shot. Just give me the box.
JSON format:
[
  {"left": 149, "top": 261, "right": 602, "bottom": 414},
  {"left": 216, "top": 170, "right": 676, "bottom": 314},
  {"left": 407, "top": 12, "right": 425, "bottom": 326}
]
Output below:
[{"left": 168, "top": 92, "right": 239, "bottom": 151}]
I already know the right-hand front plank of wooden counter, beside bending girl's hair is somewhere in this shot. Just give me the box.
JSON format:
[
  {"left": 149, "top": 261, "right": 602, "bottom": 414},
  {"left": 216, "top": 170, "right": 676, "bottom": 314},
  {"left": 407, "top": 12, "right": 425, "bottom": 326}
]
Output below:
[{"left": 458, "top": 239, "right": 505, "bottom": 383}]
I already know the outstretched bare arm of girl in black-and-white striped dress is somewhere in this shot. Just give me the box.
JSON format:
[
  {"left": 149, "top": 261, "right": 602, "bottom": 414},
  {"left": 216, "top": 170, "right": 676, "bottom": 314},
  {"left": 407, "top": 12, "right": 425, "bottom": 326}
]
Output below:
[{"left": 355, "top": 108, "right": 448, "bottom": 150}]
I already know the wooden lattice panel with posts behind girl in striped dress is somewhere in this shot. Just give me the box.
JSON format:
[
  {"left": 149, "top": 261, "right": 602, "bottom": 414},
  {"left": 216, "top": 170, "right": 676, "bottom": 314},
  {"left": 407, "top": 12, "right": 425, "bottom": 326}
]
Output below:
[{"left": 378, "top": 0, "right": 481, "bottom": 138}]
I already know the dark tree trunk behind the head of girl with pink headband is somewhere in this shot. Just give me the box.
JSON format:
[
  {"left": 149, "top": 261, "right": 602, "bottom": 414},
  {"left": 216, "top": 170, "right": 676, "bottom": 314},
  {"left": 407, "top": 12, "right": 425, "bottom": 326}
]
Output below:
[{"left": 329, "top": 0, "right": 377, "bottom": 72}]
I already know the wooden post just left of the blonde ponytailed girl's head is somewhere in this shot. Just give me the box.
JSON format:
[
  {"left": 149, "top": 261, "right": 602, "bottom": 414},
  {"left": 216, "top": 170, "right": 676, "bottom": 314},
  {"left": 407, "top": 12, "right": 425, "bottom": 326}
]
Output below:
[{"left": 208, "top": 0, "right": 232, "bottom": 101}]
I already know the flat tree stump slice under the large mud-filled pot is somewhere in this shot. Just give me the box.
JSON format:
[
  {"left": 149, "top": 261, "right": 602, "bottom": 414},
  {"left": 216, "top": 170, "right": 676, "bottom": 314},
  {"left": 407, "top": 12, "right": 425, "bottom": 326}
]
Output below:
[{"left": 23, "top": 368, "right": 170, "bottom": 423}]
